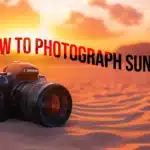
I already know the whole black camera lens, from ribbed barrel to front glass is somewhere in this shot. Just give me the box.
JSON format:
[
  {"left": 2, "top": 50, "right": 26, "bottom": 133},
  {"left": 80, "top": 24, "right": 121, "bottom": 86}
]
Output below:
[{"left": 13, "top": 82, "right": 72, "bottom": 127}]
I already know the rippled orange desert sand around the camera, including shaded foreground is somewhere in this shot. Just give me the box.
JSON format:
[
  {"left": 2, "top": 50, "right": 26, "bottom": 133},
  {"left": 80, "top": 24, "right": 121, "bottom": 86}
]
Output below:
[{"left": 0, "top": 59, "right": 150, "bottom": 150}]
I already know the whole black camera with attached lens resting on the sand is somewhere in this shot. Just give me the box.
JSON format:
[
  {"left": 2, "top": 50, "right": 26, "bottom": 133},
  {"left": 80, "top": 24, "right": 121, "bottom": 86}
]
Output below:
[{"left": 0, "top": 62, "right": 72, "bottom": 127}]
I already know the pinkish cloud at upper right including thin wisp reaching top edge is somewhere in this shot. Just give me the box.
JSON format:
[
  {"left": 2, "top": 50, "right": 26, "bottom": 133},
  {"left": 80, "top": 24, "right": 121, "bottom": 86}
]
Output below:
[{"left": 89, "top": 0, "right": 143, "bottom": 26}]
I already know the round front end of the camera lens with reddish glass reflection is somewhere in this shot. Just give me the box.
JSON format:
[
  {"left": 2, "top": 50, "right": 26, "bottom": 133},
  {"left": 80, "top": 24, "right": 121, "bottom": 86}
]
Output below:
[{"left": 38, "top": 85, "right": 72, "bottom": 126}]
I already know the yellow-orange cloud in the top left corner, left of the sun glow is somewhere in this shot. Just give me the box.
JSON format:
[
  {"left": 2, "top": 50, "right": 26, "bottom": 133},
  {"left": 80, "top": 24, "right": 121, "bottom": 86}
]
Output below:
[{"left": 0, "top": 0, "right": 40, "bottom": 30}]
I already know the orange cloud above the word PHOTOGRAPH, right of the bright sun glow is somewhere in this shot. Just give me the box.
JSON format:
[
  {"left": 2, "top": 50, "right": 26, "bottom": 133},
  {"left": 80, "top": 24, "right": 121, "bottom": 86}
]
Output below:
[{"left": 54, "top": 12, "right": 122, "bottom": 39}]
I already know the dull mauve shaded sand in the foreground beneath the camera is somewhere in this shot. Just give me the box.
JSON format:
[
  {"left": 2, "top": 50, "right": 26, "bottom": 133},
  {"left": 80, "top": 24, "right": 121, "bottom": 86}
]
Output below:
[{"left": 0, "top": 120, "right": 122, "bottom": 150}]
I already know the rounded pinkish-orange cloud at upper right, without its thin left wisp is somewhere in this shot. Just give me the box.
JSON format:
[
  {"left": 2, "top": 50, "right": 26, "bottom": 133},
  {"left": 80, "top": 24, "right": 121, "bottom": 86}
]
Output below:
[{"left": 108, "top": 4, "right": 143, "bottom": 26}]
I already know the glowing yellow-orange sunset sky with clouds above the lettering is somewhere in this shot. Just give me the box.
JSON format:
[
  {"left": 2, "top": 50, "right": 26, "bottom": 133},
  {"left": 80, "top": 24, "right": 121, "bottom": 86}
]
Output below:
[{"left": 0, "top": 0, "right": 150, "bottom": 51}]
